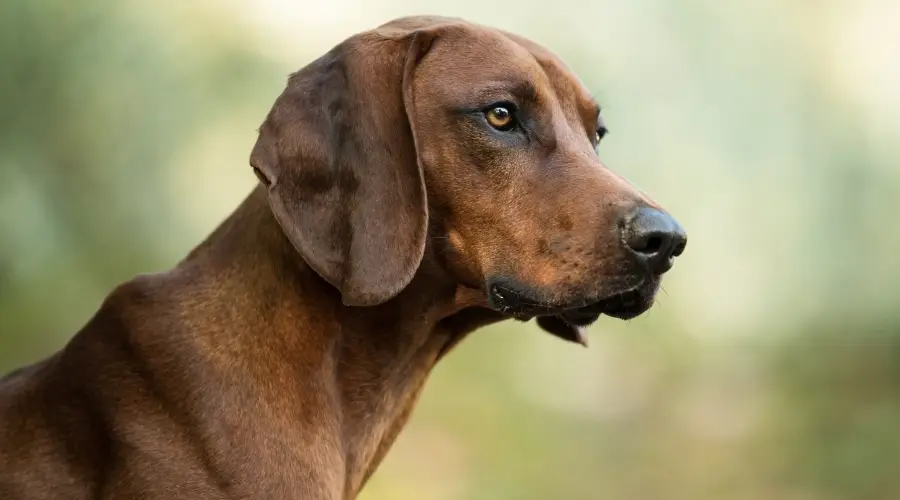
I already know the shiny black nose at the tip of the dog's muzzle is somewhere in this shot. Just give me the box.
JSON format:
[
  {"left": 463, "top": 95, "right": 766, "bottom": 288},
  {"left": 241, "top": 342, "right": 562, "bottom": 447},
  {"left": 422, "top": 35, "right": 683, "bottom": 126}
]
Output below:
[{"left": 623, "top": 207, "right": 687, "bottom": 274}]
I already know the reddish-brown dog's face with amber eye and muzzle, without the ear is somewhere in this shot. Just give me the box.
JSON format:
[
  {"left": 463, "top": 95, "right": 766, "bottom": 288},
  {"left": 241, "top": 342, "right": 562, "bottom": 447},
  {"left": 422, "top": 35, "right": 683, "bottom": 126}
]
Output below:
[{"left": 413, "top": 24, "right": 686, "bottom": 336}]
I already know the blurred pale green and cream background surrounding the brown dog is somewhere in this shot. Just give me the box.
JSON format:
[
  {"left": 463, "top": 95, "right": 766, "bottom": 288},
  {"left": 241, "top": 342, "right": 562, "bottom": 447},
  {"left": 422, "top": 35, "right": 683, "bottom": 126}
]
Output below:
[{"left": 0, "top": 0, "right": 900, "bottom": 500}]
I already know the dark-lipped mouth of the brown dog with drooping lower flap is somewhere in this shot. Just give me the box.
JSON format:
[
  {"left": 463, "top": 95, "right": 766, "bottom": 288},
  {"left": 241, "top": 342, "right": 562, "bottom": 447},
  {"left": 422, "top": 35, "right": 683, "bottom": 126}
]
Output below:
[{"left": 489, "top": 277, "right": 660, "bottom": 346}]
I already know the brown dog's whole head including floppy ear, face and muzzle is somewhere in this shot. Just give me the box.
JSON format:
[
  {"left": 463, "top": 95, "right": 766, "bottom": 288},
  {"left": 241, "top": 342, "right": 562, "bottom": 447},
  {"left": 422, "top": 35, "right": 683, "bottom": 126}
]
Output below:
[{"left": 251, "top": 17, "right": 687, "bottom": 340}]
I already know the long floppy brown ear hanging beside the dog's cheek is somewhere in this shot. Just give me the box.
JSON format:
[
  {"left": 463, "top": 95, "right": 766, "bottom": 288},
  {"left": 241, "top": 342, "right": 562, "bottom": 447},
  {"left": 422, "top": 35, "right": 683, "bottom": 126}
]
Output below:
[{"left": 250, "top": 28, "right": 434, "bottom": 306}]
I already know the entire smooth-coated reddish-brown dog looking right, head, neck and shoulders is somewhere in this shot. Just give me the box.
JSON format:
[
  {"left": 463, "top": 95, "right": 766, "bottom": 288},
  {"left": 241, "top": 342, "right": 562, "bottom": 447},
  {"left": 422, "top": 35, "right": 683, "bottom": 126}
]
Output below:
[{"left": 0, "top": 18, "right": 686, "bottom": 500}]
